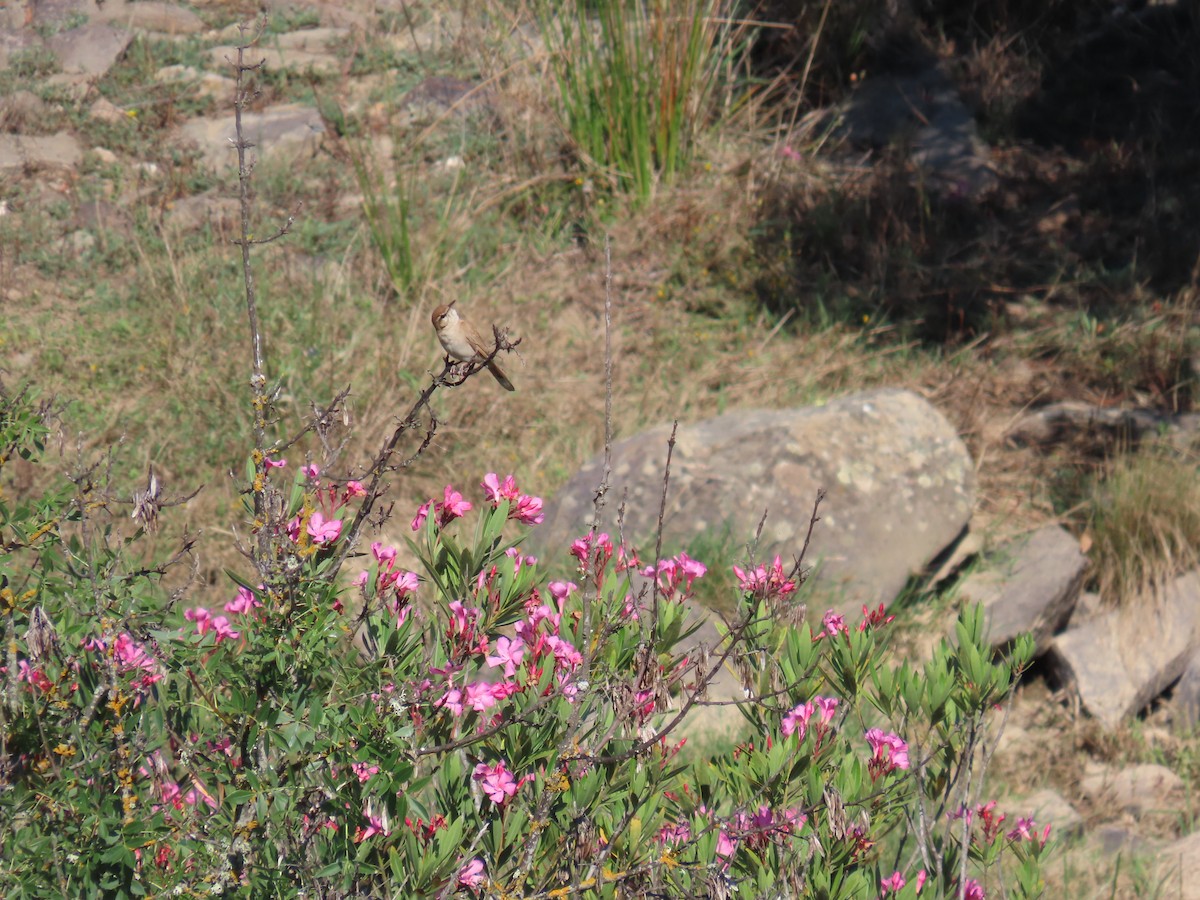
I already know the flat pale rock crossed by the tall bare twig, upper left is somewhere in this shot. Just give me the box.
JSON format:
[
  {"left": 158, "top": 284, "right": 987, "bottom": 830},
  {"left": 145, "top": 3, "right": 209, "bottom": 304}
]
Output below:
[{"left": 172, "top": 103, "right": 325, "bottom": 169}]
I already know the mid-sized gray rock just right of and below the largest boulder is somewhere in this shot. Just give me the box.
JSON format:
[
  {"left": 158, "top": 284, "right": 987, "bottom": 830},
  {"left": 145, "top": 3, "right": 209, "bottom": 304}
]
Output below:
[{"left": 959, "top": 526, "right": 1087, "bottom": 655}]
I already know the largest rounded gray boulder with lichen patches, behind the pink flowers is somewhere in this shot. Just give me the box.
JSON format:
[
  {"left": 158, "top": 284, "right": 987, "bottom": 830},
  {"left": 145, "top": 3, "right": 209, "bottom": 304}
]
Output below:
[{"left": 538, "top": 389, "right": 974, "bottom": 612}]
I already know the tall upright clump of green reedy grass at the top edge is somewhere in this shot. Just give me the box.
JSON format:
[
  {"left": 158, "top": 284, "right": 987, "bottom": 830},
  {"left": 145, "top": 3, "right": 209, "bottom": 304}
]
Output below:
[{"left": 536, "top": 0, "right": 740, "bottom": 205}]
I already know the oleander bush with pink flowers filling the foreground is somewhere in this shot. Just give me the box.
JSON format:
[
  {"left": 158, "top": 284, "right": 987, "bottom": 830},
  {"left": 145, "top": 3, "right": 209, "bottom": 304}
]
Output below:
[{"left": 0, "top": 384, "right": 1045, "bottom": 898}]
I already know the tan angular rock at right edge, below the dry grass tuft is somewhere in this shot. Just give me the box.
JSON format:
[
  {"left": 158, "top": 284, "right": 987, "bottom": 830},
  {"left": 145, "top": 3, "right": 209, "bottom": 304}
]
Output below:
[{"left": 1046, "top": 571, "right": 1200, "bottom": 728}]
